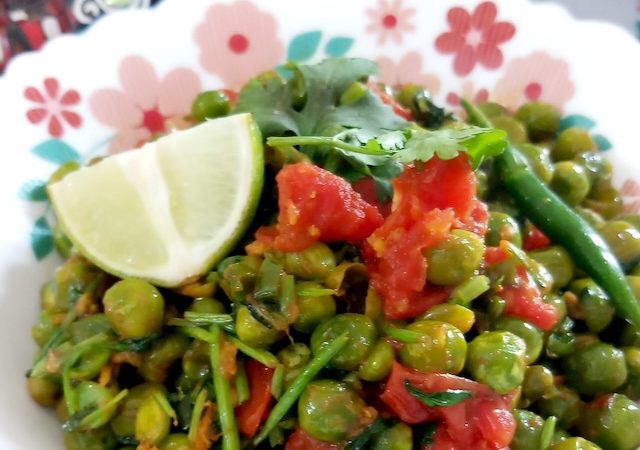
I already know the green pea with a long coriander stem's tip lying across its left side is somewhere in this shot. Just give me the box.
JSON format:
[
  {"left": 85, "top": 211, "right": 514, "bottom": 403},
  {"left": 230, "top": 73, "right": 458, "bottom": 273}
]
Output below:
[{"left": 311, "top": 313, "right": 377, "bottom": 371}]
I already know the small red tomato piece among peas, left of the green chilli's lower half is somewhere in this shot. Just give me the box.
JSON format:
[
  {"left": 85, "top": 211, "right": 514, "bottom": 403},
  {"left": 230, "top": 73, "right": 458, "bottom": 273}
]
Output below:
[{"left": 498, "top": 266, "right": 558, "bottom": 331}]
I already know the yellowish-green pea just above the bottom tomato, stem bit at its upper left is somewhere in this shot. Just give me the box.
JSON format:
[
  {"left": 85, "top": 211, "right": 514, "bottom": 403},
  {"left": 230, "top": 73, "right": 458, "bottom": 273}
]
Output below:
[{"left": 399, "top": 320, "right": 467, "bottom": 373}]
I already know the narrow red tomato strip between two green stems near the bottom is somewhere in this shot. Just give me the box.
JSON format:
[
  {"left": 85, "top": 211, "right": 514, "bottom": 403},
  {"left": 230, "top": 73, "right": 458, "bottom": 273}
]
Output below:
[{"left": 235, "top": 359, "right": 273, "bottom": 437}]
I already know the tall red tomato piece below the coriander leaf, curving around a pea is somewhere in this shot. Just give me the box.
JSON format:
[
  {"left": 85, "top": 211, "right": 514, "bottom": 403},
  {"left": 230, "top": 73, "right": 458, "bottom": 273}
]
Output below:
[{"left": 361, "top": 155, "right": 488, "bottom": 319}]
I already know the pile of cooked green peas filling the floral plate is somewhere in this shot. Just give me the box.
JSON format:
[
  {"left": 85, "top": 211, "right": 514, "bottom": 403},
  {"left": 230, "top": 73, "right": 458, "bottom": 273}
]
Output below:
[{"left": 27, "top": 85, "right": 640, "bottom": 450}]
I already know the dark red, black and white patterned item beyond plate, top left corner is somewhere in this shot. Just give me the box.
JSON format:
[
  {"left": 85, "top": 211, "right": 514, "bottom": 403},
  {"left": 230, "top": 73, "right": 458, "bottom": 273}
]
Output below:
[{"left": 0, "top": 0, "right": 160, "bottom": 74}]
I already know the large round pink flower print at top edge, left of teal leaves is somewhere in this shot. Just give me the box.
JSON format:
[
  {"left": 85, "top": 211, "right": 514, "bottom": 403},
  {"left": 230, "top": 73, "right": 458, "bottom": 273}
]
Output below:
[{"left": 194, "top": 0, "right": 284, "bottom": 88}]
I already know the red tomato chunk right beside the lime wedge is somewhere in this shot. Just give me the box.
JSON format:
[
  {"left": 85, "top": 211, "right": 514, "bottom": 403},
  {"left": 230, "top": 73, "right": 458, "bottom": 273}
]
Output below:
[{"left": 256, "top": 163, "right": 383, "bottom": 252}]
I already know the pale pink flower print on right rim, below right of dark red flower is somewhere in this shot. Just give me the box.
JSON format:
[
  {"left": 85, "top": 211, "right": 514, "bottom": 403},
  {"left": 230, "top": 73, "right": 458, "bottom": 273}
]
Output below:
[{"left": 492, "top": 51, "right": 575, "bottom": 110}]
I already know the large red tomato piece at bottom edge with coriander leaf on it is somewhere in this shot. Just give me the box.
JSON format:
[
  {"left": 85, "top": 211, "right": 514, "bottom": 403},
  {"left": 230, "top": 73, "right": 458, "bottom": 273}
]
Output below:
[{"left": 380, "top": 363, "right": 516, "bottom": 450}]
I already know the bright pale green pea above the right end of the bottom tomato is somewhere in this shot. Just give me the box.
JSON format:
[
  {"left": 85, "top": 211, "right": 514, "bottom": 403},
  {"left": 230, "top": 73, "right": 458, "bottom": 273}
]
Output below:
[{"left": 466, "top": 331, "right": 527, "bottom": 394}]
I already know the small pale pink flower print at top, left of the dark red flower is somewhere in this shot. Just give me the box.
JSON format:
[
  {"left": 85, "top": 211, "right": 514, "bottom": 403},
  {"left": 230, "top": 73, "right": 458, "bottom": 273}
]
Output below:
[{"left": 367, "top": 0, "right": 416, "bottom": 45}]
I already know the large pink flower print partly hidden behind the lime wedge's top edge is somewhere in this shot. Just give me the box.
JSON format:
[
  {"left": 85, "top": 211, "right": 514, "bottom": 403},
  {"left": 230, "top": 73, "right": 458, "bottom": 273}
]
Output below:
[{"left": 89, "top": 56, "right": 200, "bottom": 153}]
